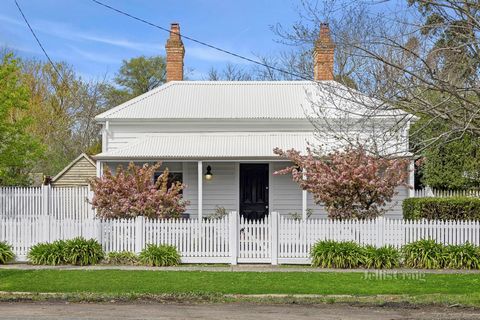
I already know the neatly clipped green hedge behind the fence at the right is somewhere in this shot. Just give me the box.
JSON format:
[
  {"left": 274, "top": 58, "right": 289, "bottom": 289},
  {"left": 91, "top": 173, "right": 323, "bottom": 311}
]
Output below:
[{"left": 402, "top": 197, "right": 480, "bottom": 220}]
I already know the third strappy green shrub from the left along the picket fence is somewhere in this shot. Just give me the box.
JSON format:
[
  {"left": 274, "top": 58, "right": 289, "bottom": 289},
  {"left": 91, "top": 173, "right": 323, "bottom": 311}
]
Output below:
[{"left": 64, "top": 237, "right": 104, "bottom": 266}]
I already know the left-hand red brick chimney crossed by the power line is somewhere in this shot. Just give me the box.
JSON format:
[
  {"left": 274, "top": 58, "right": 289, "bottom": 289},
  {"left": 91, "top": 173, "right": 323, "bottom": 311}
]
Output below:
[{"left": 165, "top": 22, "right": 185, "bottom": 82}]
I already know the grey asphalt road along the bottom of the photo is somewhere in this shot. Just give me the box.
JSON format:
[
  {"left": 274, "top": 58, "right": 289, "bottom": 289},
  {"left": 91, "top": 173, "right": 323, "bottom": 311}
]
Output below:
[{"left": 0, "top": 303, "right": 480, "bottom": 320}]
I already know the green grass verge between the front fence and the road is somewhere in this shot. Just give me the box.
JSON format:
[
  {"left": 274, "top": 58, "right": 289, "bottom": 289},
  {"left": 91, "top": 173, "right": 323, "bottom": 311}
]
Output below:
[{"left": 0, "top": 270, "right": 480, "bottom": 307}]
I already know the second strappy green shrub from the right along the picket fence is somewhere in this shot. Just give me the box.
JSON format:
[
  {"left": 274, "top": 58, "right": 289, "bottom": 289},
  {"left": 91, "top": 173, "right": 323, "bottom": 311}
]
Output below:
[{"left": 402, "top": 239, "right": 445, "bottom": 269}]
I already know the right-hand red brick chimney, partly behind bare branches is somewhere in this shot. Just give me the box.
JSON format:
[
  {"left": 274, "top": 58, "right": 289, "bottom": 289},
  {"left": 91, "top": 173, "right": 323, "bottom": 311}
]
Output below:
[{"left": 313, "top": 23, "right": 335, "bottom": 81}]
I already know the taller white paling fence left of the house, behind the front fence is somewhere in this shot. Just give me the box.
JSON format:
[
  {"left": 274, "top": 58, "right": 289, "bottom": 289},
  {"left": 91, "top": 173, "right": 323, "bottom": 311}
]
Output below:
[{"left": 0, "top": 186, "right": 94, "bottom": 220}]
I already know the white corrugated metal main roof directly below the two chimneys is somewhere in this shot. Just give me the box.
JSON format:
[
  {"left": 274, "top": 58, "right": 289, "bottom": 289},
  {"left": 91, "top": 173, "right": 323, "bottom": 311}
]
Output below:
[{"left": 96, "top": 81, "right": 404, "bottom": 120}]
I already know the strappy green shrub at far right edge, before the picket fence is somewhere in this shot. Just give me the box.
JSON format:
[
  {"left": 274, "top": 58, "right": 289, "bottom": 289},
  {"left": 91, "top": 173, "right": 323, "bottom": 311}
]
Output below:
[{"left": 445, "top": 243, "right": 480, "bottom": 269}]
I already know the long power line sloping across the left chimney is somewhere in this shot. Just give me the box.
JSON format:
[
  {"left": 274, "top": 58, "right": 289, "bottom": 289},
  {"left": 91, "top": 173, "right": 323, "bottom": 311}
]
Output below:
[{"left": 90, "top": 0, "right": 313, "bottom": 81}]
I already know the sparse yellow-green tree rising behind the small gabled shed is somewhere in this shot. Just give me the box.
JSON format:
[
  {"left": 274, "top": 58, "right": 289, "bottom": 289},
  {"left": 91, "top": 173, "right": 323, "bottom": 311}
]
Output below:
[{"left": 22, "top": 60, "right": 106, "bottom": 175}]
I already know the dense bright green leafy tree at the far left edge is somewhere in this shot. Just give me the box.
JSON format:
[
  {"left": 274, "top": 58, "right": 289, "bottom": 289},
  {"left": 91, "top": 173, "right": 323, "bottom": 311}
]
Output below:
[{"left": 0, "top": 53, "right": 43, "bottom": 185}]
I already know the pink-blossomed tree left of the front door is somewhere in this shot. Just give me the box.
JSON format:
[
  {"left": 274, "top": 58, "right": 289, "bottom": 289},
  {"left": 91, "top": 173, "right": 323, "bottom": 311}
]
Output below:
[{"left": 90, "top": 163, "right": 188, "bottom": 219}]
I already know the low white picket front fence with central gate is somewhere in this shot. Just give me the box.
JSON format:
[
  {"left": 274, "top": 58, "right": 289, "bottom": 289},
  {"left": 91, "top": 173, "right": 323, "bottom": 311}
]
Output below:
[{"left": 0, "top": 212, "right": 480, "bottom": 264}]
